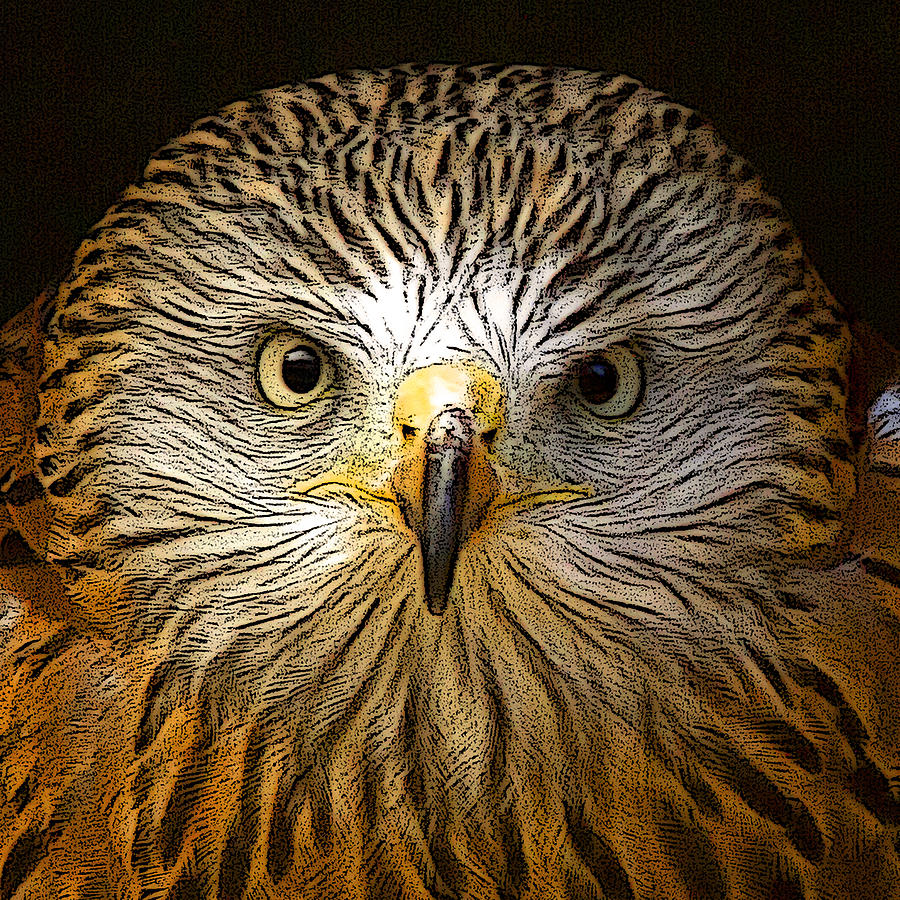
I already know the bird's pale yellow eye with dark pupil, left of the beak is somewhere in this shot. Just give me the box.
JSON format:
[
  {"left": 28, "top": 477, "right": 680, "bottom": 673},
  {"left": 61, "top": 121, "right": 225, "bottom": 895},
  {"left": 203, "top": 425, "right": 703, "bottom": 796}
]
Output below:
[{"left": 257, "top": 334, "right": 328, "bottom": 409}]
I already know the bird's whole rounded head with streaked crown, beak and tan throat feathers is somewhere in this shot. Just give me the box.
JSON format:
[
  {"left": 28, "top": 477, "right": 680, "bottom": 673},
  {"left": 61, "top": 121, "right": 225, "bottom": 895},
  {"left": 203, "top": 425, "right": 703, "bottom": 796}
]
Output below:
[{"left": 5, "top": 66, "right": 872, "bottom": 896}]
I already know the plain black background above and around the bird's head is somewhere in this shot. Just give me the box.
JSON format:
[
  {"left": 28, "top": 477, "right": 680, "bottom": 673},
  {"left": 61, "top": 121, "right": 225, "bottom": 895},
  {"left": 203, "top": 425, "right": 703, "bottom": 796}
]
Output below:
[{"left": 0, "top": 0, "right": 900, "bottom": 343}]
